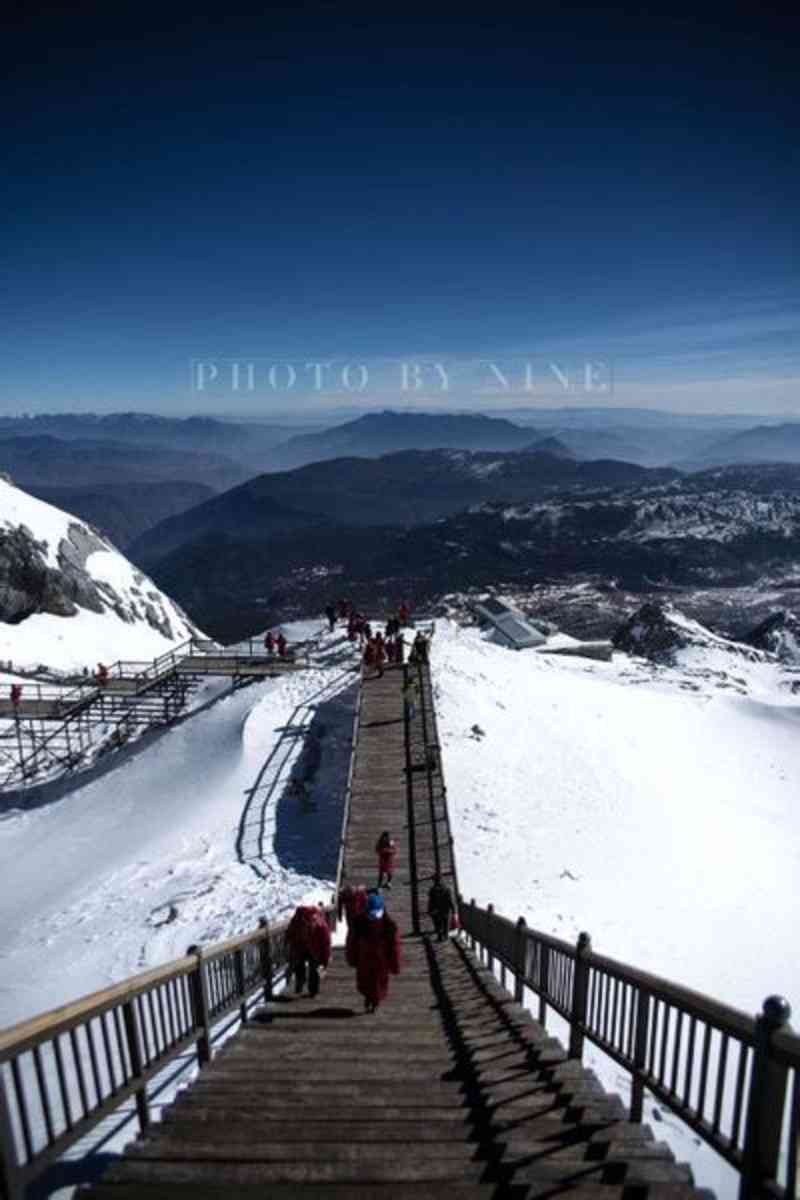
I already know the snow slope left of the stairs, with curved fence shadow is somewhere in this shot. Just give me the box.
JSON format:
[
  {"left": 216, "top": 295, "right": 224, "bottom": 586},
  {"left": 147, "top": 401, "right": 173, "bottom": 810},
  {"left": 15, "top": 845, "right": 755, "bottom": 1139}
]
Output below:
[{"left": 0, "top": 664, "right": 355, "bottom": 1027}]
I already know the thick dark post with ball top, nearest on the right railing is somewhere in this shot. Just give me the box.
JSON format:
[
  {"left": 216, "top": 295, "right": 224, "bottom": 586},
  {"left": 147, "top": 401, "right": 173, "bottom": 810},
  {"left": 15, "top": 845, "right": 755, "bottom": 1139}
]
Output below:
[{"left": 739, "top": 996, "right": 792, "bottom": 1200}]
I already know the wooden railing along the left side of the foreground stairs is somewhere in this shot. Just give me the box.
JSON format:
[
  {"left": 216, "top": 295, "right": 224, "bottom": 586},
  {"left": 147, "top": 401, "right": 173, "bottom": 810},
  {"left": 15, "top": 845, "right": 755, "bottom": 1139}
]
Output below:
[{"left": 0, "top": 908, "right": 336, "bottom": 1200}]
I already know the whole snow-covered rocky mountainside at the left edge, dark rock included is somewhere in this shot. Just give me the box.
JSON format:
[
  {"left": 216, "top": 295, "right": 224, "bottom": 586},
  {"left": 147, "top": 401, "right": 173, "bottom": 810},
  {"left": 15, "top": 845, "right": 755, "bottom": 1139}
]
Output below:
[{"left": 0, "top": 479, "right": 196, "bottom": 672}]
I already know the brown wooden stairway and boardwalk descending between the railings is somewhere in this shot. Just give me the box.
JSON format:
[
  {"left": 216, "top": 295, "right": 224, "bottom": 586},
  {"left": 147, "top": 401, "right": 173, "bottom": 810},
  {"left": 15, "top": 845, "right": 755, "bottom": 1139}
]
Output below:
[{"left": 82, "top": 668, "right": 697, "bottom": 1200}]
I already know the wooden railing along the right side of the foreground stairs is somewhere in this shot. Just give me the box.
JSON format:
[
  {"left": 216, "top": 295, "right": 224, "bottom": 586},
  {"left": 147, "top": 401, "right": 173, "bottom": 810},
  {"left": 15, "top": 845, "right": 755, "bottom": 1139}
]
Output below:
[{"left": 458, "top": 896, "right": 800, "bottom": 1200}]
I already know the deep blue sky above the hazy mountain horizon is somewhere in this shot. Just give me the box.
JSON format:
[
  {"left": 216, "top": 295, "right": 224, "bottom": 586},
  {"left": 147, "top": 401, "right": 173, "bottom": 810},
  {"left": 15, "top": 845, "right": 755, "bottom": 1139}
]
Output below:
[{"left": 0, "top": 2, "right": 800, "bottom": 415}]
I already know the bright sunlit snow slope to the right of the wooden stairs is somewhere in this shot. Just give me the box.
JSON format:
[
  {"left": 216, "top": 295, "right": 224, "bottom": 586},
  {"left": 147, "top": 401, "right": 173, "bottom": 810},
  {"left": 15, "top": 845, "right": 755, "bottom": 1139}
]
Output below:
[{"left": 432, "top": 622, "right": 800, "bottom": 1195}]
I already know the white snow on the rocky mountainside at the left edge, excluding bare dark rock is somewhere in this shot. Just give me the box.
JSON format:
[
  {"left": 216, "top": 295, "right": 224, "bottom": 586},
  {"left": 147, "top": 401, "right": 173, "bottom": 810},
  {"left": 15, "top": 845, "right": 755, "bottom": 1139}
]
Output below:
[{"left": 0, "top": 479, "right": 199, "bottom": 671}]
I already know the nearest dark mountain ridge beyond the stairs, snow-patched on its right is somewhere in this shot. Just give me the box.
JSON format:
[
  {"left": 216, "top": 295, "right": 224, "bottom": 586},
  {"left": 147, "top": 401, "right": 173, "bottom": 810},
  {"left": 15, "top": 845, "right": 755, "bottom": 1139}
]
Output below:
[{"left": 139, "top": 456, "right": 800, "bottom": 637}]
